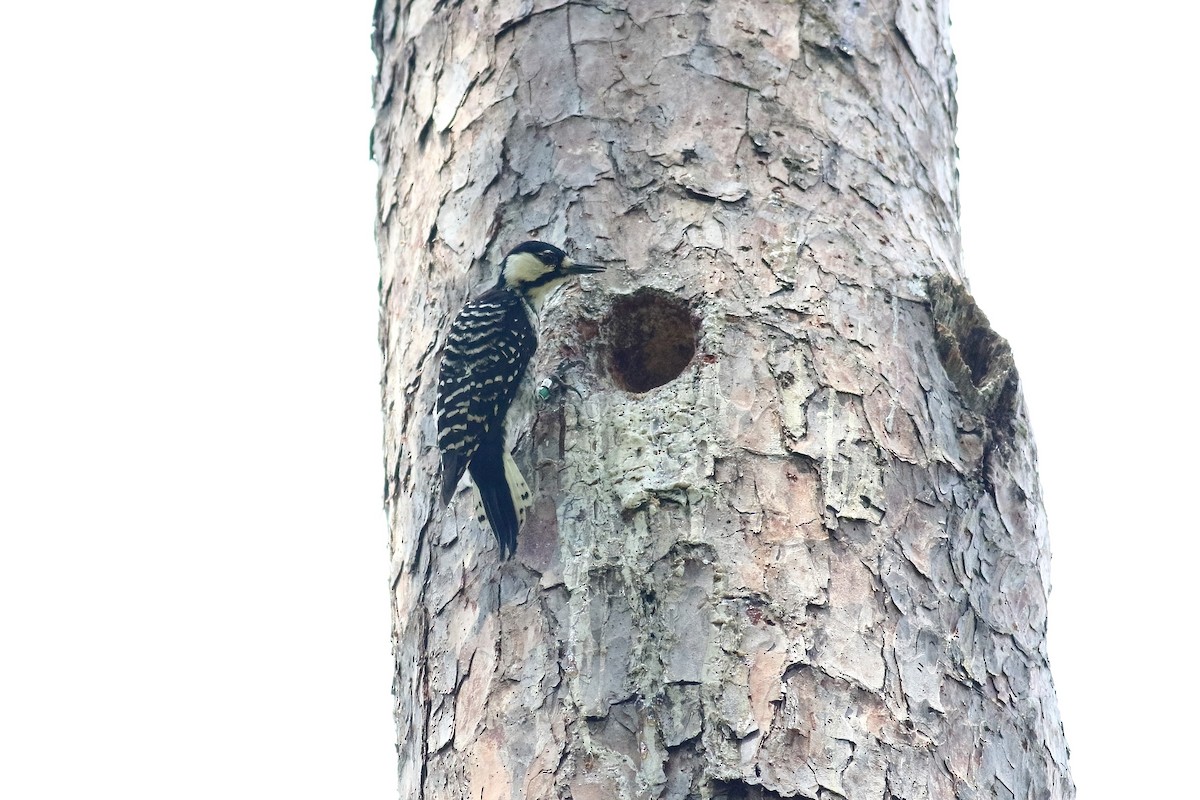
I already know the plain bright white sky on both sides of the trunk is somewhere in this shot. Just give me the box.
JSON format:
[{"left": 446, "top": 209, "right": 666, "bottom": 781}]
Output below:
[{"left": 0, "top": 0, "right": 1200, "bottom": 800}]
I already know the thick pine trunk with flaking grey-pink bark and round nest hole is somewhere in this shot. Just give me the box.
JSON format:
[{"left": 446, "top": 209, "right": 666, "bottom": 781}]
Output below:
[{"left": 373, "top": 0, "right": 1074, "bottom": 800}]
